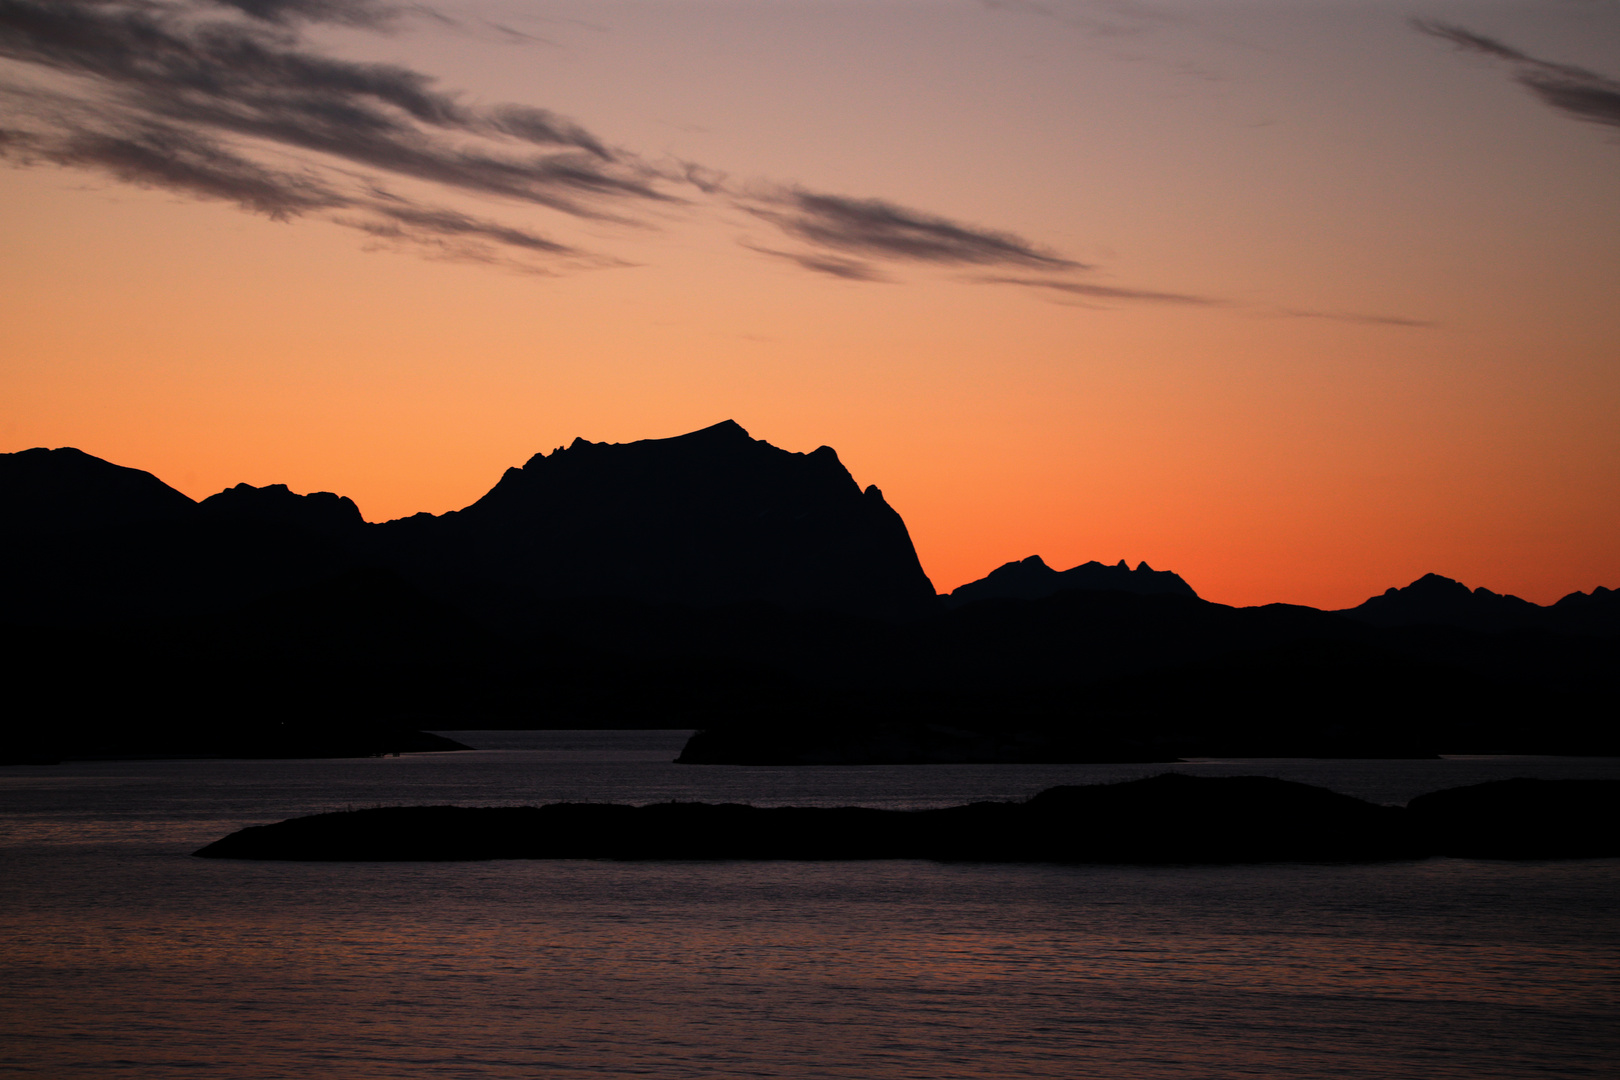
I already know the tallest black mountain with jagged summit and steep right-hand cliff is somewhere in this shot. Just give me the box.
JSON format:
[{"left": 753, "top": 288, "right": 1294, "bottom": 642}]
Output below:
[{"left": 377, "top": 421, "right": 935, "bottom": 614}]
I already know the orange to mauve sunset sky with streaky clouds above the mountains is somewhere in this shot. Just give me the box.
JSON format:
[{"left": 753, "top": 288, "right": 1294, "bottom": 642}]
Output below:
[{"left": 0, "top": 0, "right": 1620, "bottom": 607}]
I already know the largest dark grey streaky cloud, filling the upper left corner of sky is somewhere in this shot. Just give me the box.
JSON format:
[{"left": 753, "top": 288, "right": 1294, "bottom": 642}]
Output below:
[{"left": 0, "top": 0, "right": 664, "bottom": 264}]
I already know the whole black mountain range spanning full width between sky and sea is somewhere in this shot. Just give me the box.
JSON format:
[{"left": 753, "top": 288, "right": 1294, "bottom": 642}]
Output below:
[{"left": 0, "top": 421, "right": 1620, "bottom": 763}]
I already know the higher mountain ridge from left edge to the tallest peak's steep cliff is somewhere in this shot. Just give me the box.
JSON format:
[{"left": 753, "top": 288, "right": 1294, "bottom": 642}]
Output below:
[{"left": 0, "top": 421, "right": 935, "bottom": 623}]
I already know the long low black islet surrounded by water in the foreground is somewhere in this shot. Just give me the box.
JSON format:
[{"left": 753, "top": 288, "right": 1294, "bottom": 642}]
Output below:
[{"left": 196, "top": 772, "right": 1620, "bottom": 863}]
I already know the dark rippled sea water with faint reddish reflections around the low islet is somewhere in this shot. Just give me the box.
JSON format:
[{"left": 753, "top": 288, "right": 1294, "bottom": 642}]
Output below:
[{"left": 0, "top": 732, "right": 1620, "bottom": 1080}]
